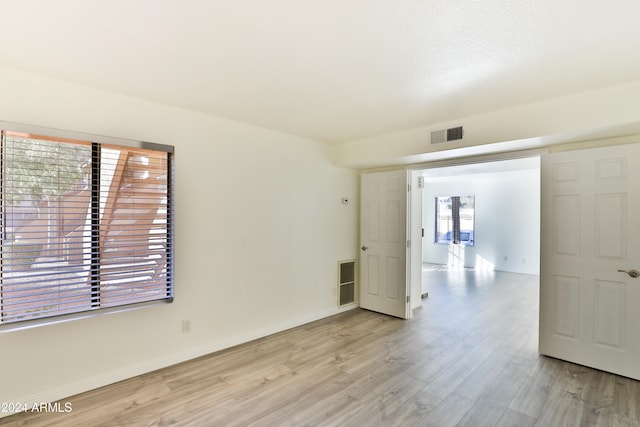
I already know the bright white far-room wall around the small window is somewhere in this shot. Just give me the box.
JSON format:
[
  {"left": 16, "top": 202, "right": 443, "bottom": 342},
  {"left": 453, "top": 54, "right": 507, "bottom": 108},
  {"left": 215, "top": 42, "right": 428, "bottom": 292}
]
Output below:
[{"left": 422, "top": 169, "right": 540, "bottom": 274}]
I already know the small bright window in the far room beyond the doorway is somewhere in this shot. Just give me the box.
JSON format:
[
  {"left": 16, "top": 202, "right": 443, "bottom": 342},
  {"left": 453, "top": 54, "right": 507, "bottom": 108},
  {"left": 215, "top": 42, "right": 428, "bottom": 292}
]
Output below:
[{"left": 435, "top": 196, "right": 475, "bottom": 246}]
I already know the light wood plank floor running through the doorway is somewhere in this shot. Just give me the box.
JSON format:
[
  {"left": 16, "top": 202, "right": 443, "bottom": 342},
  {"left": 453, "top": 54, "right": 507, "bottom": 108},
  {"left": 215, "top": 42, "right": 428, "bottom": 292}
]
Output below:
[{"left": 0, "top": 268, "right": 640, "bottom": 427}]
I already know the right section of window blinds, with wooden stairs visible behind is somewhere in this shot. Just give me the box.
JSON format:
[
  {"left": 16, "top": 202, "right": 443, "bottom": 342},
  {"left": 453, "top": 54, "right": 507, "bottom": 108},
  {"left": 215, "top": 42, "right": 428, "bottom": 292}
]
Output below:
[{"left": 99, "top": 145, "right": 173, "bottom": 307}]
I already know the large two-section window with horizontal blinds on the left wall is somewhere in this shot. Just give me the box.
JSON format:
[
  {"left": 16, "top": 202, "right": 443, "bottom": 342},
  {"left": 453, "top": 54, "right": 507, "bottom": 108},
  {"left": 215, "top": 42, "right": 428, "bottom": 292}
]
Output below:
[{"left": 0, "top": 131, "right": 173, "bottom": 324}]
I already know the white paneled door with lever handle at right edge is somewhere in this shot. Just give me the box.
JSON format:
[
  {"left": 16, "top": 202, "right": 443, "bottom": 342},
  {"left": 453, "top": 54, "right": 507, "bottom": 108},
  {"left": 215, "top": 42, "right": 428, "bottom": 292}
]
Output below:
[{"left": 540, "top": 144, "right": 640, "bottom": 379}]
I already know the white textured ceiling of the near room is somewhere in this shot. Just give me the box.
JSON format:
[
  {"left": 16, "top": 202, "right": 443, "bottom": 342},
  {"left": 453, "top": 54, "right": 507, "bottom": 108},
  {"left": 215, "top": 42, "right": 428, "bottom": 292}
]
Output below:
[{"left": 0, "top": 0, "right": 640, "bottom": 143}]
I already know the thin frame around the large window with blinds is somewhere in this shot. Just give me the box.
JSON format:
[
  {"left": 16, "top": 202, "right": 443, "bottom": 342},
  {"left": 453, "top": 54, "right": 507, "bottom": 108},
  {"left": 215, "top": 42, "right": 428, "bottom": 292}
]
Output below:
[{"left": 0, "top": 121, "right": 175, "bottom": 332}]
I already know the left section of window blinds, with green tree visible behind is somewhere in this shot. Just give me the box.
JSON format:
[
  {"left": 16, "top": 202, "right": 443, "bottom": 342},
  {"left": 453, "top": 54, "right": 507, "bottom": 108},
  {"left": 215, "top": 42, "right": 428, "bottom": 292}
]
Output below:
[{"left": 0, "top": 132, "right": 92, "bottom": 323}]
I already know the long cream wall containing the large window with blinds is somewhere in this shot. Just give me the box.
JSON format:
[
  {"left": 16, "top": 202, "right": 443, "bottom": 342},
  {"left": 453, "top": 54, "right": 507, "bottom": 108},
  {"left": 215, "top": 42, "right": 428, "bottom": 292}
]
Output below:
[{"left": 0, "top": 69, "right": 358, "bottom": 412}]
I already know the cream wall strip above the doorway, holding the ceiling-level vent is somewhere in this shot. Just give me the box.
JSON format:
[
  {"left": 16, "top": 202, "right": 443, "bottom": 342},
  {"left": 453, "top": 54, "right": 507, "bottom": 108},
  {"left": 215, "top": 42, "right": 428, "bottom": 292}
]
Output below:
[{"left": 332, "top": 80, "right": 640, "bottom": 167}]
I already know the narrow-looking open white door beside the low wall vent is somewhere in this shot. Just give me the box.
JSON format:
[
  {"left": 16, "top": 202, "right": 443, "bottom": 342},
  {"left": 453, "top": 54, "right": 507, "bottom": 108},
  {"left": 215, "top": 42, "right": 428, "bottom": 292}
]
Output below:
[{"left": 360, "top": 171, "right": 411, "bottom": 319}]
